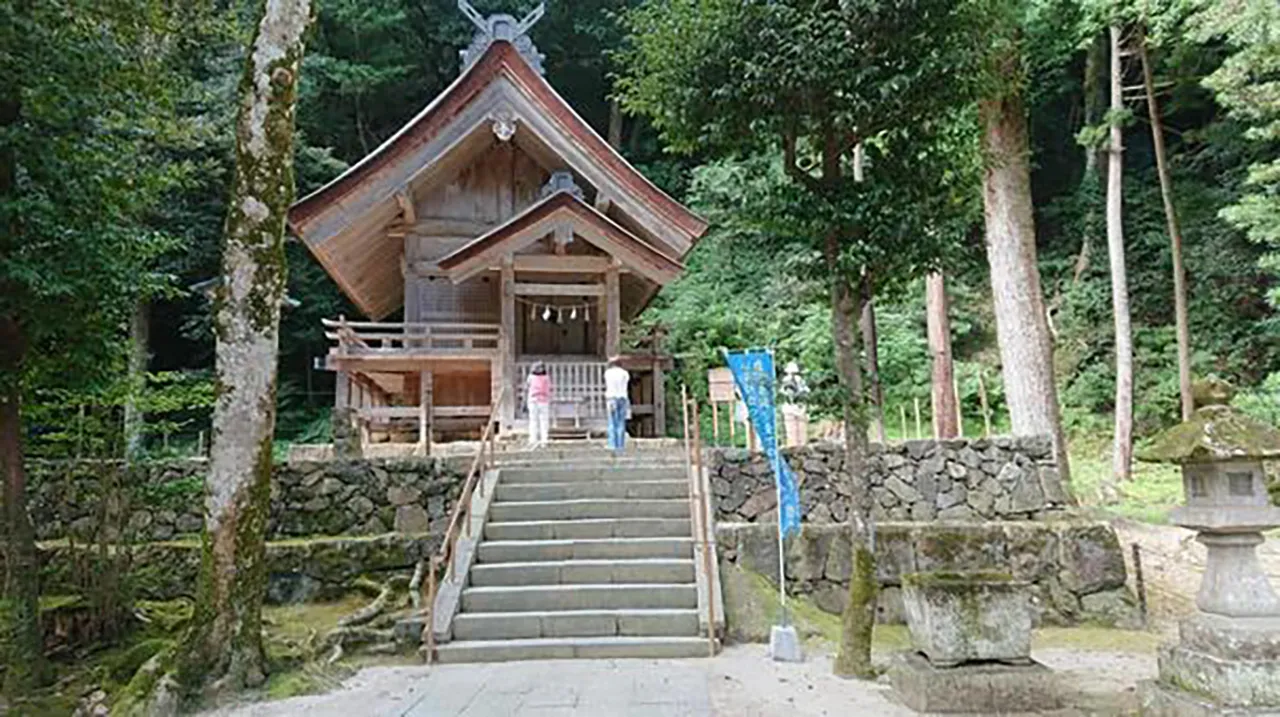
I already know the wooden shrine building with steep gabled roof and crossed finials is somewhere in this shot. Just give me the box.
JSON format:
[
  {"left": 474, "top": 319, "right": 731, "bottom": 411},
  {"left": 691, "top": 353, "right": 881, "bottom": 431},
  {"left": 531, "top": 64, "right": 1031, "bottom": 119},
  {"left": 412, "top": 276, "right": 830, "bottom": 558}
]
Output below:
[{"left": 289, "top": 1, "right": 707, "bottom": 442}]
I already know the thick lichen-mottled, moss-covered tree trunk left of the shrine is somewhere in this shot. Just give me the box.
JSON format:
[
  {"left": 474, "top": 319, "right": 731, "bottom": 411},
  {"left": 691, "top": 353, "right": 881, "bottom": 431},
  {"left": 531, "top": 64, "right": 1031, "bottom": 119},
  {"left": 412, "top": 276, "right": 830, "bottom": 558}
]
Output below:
[{"left": 178, "top": 0, "right": 311, "bottom": 693}]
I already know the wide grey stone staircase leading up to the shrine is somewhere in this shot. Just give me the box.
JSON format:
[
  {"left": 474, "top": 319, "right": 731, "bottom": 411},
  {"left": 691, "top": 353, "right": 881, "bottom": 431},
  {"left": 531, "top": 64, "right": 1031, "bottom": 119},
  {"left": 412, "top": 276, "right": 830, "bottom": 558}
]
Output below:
[{"left": 436, "top": 449, "right": 708, "bottom": 662}]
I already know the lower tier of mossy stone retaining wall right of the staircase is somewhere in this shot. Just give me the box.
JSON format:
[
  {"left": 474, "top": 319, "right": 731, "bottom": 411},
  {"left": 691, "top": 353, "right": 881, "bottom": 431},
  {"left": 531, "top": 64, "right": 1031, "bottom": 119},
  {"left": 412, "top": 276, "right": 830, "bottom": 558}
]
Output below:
[{"left": 716, "top": 520, "right": 1138, "bottom": 631}]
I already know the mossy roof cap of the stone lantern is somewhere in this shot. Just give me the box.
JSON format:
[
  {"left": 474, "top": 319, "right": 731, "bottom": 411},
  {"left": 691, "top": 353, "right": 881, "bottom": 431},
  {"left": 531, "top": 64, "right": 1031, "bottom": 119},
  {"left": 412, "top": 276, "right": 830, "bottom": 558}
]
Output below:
[{"left": 1138, "top": 387, "right": 1280, "bottom": 463}]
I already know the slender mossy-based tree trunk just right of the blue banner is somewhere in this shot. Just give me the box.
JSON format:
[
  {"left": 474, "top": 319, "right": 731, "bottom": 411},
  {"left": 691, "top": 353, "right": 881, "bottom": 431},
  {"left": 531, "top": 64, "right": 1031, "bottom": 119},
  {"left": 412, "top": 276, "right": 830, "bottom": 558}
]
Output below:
[{"left": 824, "top": 234, "right": 879, "bottom": 679}]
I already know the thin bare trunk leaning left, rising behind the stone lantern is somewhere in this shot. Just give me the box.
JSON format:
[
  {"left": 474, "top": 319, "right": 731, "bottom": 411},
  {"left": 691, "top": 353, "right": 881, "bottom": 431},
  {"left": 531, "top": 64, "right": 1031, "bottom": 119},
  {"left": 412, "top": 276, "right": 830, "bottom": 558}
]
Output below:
[{"left": 1138, "top": 29, "right": 1196, "bottom": 421}]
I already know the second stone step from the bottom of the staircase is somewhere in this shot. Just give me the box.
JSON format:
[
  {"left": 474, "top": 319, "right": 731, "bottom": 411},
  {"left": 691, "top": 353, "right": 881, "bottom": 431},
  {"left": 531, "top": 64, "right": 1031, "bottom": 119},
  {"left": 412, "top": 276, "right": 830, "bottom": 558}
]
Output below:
[{"left": 453, "top": 609, "right": 698, "bottom": 640}]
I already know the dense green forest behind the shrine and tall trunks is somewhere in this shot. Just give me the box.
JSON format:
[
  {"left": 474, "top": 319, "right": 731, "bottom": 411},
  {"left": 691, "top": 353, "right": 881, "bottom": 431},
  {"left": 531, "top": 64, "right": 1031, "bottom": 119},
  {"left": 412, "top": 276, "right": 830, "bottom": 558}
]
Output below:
[{"left": 17, "top": 0, "right": 1280, "bottom": 499}]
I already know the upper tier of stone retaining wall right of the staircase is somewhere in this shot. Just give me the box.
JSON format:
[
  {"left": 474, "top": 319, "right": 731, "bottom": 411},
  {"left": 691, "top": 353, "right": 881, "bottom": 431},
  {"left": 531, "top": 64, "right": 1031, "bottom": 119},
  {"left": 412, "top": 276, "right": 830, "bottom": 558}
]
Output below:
[{"left": 710, "top": 437, "right": 1069, "bottom": 524}]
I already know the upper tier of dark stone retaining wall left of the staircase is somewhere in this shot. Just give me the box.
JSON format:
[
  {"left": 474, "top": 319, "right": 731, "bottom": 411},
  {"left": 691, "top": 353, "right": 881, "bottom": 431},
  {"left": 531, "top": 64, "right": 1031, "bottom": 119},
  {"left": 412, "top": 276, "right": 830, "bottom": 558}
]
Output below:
[{"left": 27, "top": 458, "right": 465, "bottom": 540}]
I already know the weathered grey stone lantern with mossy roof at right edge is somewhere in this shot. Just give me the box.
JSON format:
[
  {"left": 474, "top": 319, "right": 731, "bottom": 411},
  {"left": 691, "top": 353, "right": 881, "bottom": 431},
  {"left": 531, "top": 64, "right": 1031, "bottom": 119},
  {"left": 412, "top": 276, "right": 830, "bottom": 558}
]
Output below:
[{"left": 1140, "top": 391, "right": 1280, "bottom": 717}]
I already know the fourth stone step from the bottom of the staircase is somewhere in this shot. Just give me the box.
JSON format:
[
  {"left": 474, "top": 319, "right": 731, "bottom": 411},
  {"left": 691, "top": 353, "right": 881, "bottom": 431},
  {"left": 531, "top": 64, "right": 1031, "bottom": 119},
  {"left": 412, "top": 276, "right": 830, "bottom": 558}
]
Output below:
[{"left": 471, "top": 558, "right": 694, "bottom": 586}]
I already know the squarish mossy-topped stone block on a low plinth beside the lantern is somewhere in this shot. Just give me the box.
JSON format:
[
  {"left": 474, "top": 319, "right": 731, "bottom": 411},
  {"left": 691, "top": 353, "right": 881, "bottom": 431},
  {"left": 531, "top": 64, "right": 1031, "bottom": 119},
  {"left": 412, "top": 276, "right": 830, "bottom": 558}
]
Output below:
[{"left": 902, "top": 572, "right": 1032, "bottom": 667}]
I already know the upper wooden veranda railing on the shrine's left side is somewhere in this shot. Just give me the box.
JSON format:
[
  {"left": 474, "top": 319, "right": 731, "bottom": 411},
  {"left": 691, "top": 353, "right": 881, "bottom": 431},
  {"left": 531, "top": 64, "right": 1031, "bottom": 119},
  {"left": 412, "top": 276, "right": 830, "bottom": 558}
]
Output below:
[{"left": 320, "top": 316, "right": 502, "bottom": 357}]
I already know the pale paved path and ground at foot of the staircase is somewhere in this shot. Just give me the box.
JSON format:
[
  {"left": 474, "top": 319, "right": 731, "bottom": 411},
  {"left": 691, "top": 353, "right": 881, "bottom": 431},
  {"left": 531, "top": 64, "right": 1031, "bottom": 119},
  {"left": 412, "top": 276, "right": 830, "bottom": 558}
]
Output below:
[{"left": 209, "top": 645, "right": 913, "bottom": 717}]
